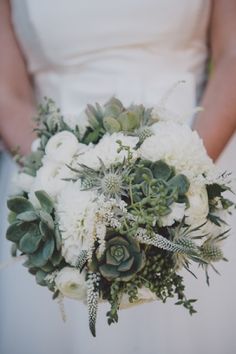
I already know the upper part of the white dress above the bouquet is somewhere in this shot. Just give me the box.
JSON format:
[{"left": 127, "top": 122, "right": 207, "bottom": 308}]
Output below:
[{"left": 11, "top": 0, "right": 211, "bottom": 114}]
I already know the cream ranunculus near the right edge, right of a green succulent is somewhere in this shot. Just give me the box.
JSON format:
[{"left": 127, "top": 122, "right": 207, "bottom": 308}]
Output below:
[{"left": 185, "top": 184, "right": 209, "bottom": 225}]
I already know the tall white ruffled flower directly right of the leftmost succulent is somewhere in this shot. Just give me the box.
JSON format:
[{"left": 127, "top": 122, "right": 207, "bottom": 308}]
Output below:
[{"left": 56, "top": 181, "right": 96, "bottom": 265}]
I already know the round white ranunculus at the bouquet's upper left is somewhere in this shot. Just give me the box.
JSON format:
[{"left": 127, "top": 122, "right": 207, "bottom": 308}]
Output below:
[{"left": 45, "top": 131, "right": 79, "bottom": 163}]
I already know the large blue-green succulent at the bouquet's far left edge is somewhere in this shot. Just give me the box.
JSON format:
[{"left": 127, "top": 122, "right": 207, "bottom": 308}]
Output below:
[{"left": 6, "top": 191, "right": 63, "bottom": 290}]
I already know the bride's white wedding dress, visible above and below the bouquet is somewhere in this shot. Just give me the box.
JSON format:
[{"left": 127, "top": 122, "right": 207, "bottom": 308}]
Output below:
[{"left": 0, "top": 0, "right": 236, "bottom": 354}]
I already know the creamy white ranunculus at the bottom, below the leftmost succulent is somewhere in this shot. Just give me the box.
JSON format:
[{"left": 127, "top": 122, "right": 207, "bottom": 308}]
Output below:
[{"left": 55, "top": 267, "right": 87, "bottom": 300}]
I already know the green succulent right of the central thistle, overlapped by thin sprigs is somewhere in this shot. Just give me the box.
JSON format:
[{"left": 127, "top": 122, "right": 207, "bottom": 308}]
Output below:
[{"left": 130, "top": 160, "right": 189, "bottom": 225}]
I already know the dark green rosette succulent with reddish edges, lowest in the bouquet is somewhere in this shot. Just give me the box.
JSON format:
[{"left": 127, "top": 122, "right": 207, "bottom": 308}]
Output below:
[{"left": 99, "top": 235, "right": 145, "bottom": 282}]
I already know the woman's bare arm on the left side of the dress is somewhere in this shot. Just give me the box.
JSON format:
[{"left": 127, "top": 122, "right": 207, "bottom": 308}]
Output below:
[{"left": 0, "top": 0, "right": 34, "bottom": 153}]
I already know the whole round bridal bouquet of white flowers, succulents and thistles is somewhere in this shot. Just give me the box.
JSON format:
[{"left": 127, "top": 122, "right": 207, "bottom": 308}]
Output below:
[{"left": 6, "top": 97, "right": 233, "bottom": 336}]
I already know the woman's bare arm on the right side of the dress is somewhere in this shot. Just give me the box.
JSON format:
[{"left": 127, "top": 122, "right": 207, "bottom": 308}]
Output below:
[{"left": 194, "top": 0, "right": 236, "bottom": 159}]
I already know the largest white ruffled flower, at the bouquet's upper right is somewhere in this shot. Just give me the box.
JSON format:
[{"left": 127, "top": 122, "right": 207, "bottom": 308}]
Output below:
[{"left": 140, "top": 122, "right": 214, "bottom": 179}]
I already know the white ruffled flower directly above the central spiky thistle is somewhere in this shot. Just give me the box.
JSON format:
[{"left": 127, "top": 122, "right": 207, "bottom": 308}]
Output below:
[{"left": 79, "top": 133, "right": 138, "bottom": 170}]
